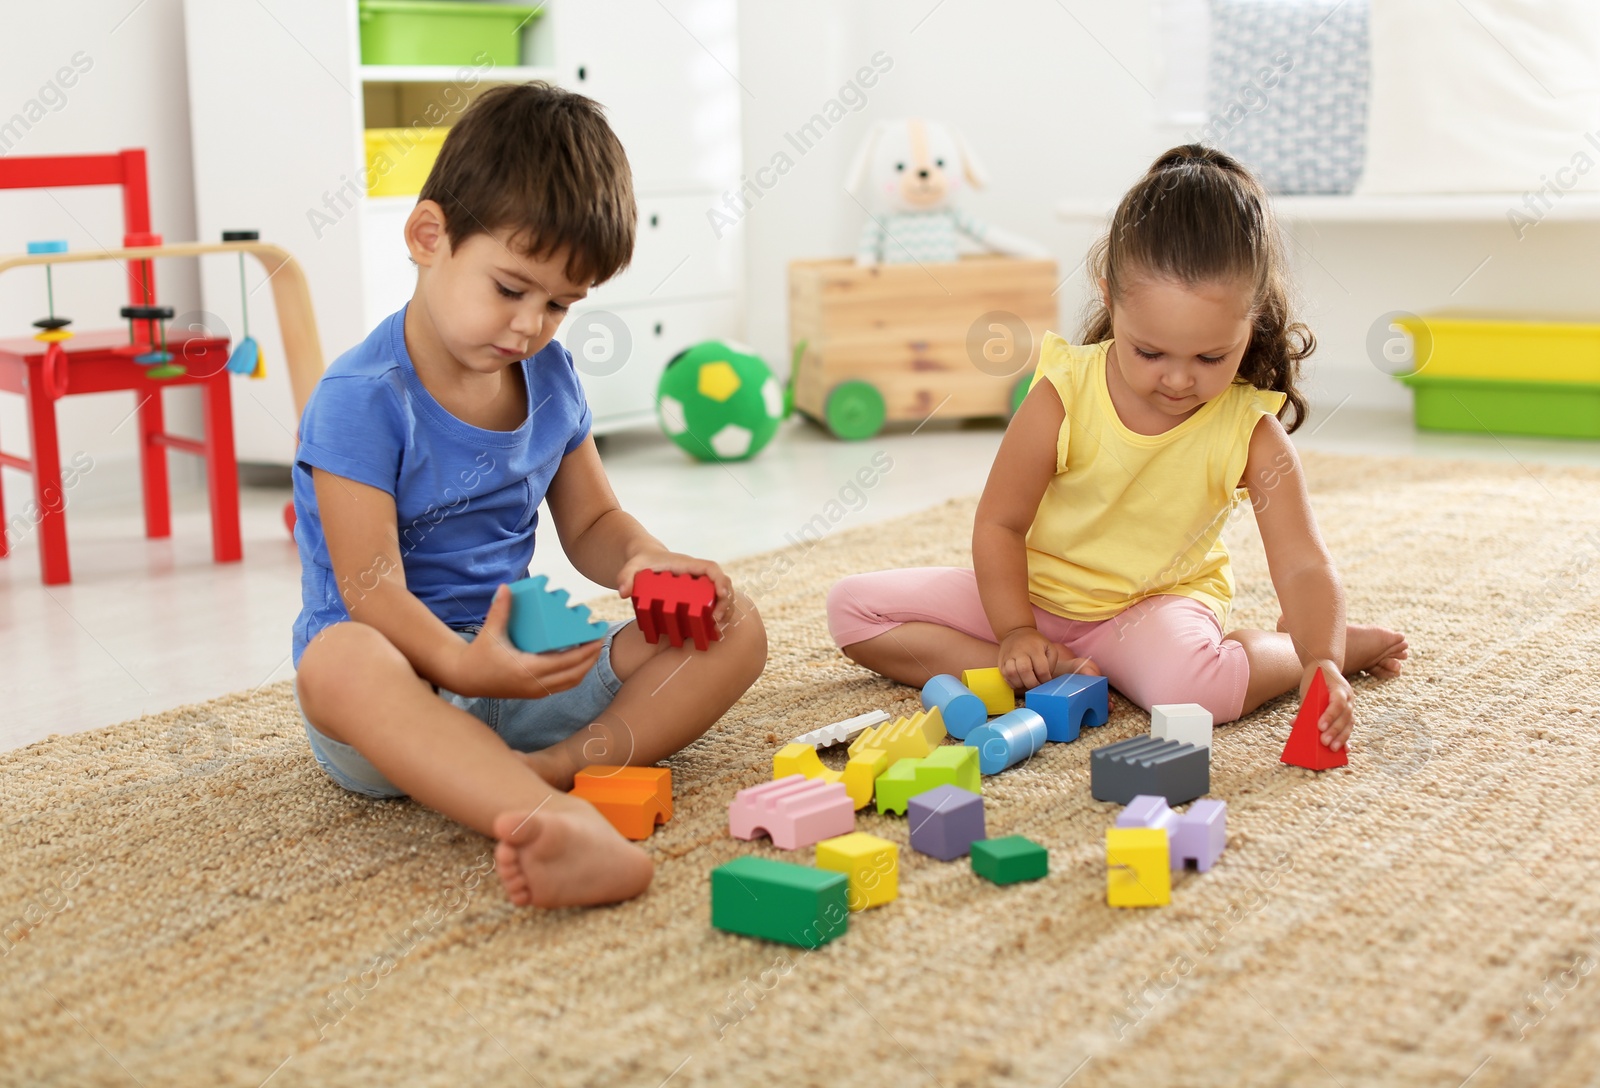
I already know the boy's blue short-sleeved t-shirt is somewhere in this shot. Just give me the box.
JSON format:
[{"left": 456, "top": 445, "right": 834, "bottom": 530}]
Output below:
[{"left": 294, "top": 307, "right": 592, "bottom": 669}]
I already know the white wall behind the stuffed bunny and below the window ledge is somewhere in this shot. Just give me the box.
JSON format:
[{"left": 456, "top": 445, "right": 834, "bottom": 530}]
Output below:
[{"left": 739, "top": 0, "right": 1600, "bottom": 426}]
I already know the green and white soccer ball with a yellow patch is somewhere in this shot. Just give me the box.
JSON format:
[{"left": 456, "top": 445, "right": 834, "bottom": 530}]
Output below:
[{"left": 656, "top": 341, "right": 789, "bottom": 461}]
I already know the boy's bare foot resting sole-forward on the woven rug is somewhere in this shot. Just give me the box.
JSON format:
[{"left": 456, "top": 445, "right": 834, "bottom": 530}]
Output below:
[{"left": 494, "top": 795, "right": 656, "bottom": 907}]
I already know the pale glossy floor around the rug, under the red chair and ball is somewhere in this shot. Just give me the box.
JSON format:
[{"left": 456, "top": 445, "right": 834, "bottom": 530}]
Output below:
[{"left": 0, "top": 410, "right": 1600, "bottom": 750}]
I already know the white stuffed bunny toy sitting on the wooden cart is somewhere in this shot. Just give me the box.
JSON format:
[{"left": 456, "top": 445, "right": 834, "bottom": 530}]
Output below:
[{"left": 845, "top": 117, "right": 1050, "bottom": 266}]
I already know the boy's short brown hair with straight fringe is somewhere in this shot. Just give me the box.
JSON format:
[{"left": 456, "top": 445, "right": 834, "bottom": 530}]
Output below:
[{"left": 418, "top": 82, "right": 638, "bottom": 283}]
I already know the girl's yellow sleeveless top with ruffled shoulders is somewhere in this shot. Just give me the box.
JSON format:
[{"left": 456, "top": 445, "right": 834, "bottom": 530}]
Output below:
[{"left": 1027, "top": 333, "right": 1285, "bottom": 632}]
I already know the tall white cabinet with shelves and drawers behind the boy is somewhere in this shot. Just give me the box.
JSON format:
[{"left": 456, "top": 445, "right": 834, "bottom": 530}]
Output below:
[{"left": 184, "top": 0, "right": 744, "bottom": 464}]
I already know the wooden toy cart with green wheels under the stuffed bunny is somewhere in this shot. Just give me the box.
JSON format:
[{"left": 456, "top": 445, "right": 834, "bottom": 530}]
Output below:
[{"left": 789, "top": 256, "right": 1058, "bottom": 438}]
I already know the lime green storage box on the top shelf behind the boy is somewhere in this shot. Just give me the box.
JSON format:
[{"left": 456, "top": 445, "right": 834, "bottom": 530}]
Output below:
[{"left": 357, "top": 0, "right": 542, "bottom": 67}]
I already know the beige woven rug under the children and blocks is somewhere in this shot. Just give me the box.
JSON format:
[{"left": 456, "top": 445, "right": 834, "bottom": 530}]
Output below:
[{"left": 0, "top": 458, "right": 1600, "bottom": 1088}]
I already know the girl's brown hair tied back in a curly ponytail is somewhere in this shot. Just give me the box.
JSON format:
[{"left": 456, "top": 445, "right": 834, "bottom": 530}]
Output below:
[{"left": 1082, "top": 144, "right": 1317, "bottom": 430}]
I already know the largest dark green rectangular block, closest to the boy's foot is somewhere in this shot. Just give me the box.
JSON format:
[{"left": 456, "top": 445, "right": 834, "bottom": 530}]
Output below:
[{"left": 710, "top": 858, "right": 850, "bottom": 949}]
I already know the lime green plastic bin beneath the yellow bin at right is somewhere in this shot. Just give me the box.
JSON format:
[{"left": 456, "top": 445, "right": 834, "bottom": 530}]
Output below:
[{"left": 1400, "top": 374, "right": 1600, "bottom": 438}]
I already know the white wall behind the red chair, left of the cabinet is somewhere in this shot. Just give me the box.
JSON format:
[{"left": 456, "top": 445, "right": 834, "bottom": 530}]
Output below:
[{"left": 0, "top": 0, "right": 206, "bottom": 514}]
